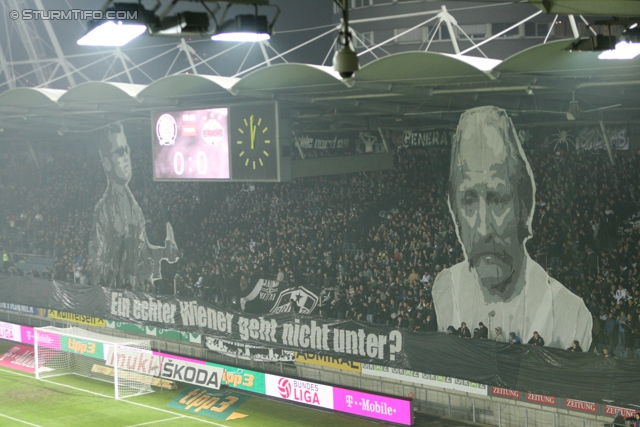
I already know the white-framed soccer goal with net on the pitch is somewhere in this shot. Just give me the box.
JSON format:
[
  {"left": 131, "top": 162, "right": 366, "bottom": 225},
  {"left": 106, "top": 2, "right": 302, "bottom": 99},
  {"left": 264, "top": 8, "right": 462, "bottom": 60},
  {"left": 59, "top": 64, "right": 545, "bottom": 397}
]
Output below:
[{"left": 34, "top": 326, "right": 159, "bottom": 399}]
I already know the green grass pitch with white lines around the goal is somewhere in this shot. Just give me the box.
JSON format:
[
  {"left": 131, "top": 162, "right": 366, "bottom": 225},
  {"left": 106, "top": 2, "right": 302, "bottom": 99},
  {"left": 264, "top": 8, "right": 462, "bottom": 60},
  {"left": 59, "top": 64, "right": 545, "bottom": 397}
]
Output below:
[{"left": 0, "top": 341, "right": 381, "bottom": 427}]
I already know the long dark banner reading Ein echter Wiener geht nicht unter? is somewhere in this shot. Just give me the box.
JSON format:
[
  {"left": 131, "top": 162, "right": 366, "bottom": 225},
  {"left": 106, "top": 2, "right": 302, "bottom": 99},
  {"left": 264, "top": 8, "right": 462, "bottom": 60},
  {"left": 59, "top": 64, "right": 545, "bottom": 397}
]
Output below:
[{"left": 0, "top": 275, "right": 640, "bottom": 405}]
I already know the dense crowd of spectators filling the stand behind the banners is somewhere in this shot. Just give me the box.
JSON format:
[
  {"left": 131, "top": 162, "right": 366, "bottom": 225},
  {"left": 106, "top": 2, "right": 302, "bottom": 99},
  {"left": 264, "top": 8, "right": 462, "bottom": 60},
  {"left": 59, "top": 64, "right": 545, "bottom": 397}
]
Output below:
[{"left": 0, "top": 135, "right": 640, "bottom": 357}]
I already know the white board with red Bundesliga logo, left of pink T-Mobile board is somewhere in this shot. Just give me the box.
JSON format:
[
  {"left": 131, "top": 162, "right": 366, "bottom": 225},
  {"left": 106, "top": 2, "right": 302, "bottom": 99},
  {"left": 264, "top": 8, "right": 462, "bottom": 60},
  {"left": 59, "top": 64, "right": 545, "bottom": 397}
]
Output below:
[{"left": 265, "top": 374, "right": 333, "bottom": 409}]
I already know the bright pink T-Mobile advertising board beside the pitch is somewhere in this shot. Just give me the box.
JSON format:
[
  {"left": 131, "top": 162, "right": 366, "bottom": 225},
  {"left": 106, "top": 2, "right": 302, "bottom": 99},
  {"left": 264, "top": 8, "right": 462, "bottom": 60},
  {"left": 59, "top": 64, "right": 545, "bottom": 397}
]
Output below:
[{"left": 333, "top": 387, "right": 413, "bottom": 425}]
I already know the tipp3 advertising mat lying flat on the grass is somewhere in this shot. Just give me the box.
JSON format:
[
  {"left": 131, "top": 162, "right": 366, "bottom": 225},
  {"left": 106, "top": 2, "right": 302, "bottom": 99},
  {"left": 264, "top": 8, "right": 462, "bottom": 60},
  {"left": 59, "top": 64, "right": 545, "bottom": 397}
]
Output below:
[{"left": 167, "top": 388, "right": 249, "bottom": 421}]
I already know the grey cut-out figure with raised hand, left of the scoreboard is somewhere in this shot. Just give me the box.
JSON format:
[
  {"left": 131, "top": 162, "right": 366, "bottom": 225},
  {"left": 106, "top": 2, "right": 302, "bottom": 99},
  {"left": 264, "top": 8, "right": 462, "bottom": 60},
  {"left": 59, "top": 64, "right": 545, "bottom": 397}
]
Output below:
[{"left": 89, "top": 123, "right": 179, "bottom": 291}]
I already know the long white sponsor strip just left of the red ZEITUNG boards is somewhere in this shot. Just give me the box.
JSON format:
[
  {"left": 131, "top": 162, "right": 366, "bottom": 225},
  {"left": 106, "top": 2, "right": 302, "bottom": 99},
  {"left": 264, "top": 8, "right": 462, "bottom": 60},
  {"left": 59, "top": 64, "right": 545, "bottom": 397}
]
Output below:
[{"left": 362, "top": 363, "right": 489, "bottom": 396}]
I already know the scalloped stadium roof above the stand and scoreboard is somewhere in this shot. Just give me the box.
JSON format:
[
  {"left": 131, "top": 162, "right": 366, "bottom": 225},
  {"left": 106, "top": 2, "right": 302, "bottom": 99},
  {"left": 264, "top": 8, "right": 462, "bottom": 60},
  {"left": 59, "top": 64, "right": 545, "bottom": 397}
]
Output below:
[{"left": 0, "top": 40, "right": 640, "bottom": 140}]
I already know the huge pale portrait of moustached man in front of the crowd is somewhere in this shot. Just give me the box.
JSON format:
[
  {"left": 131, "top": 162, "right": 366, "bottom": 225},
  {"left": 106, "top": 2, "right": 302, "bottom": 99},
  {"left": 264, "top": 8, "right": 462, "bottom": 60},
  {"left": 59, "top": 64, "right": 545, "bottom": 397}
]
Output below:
[{"left": 433, "top": 106, "right": 592, "bottom": 348}]
